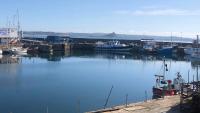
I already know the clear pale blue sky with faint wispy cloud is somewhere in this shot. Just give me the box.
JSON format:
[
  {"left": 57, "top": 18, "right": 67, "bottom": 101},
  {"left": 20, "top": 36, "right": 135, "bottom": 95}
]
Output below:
[{"left": 0, "top": 0, "right": 200, "bottom": 38}]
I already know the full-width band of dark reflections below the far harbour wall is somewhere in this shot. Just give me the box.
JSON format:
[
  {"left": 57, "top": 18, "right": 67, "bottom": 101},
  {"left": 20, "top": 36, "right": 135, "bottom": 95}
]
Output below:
[{"left": 0, "top": 51, "right": 200, "bottom": 67}]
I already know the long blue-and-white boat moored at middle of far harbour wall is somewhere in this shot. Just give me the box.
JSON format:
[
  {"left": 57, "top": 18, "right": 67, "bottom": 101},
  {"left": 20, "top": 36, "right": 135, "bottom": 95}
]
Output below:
[{"left": 95, "top": 41, "right": 132, "bottom": 52}]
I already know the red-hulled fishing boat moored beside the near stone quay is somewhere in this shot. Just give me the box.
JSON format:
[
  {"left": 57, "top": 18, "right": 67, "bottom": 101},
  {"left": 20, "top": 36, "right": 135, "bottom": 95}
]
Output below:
[{"left": 153, "top": 60, "right": 184, "bottom": 98}]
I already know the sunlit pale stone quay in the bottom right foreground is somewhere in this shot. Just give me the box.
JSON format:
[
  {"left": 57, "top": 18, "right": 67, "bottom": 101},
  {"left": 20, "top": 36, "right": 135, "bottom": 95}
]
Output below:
[{"left": 86, "top": 95, "right": 180, "bottom": 113}]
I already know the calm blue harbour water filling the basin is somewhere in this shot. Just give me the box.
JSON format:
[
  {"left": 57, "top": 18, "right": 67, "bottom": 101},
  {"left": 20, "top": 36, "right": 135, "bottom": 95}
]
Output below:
[{"left": 0, "top": 53, "right": 196, "bottom": 113}]
